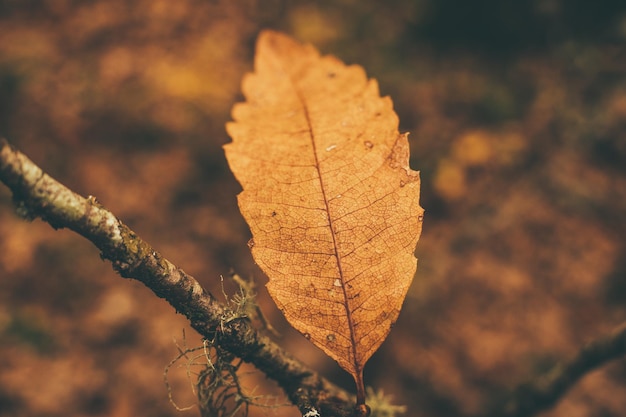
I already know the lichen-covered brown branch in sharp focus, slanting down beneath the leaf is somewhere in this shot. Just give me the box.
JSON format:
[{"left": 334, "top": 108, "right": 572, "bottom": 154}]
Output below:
[{"left": 0, "top": 138, "right": 354, "bottom": 417}]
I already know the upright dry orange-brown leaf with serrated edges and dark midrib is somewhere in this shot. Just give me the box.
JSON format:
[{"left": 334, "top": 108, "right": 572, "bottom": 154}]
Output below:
[{"left": 224, "top": 31, "right": 423, "bottom": 404}]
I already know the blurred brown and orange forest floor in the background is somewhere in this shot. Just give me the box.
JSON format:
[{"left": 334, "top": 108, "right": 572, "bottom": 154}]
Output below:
[{"left": 0, "top": 0, "right": 626, "bottom": 417}]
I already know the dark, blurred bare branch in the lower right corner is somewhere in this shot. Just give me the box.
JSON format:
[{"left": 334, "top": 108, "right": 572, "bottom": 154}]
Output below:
[{"left": 486, "top": 324, "right": 626, "bottom": 417}]
